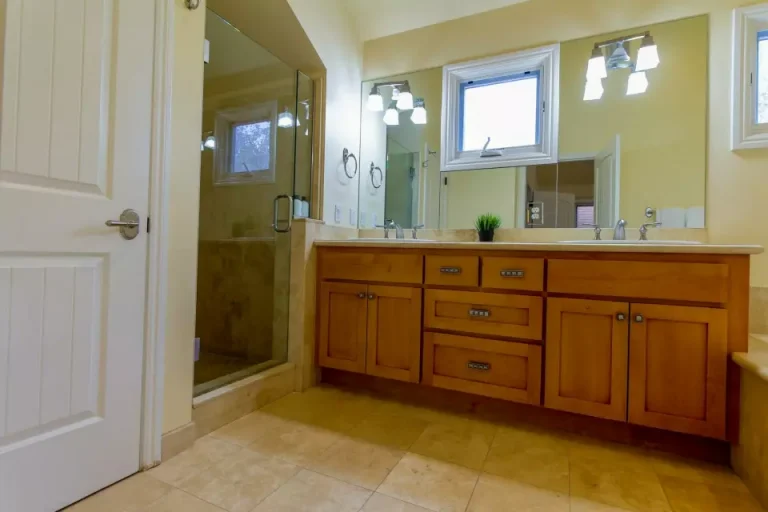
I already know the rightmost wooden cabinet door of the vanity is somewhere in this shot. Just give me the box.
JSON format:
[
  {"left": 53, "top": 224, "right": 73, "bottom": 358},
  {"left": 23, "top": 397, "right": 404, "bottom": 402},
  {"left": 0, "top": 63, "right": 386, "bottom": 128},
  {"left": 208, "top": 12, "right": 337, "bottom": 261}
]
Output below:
[{"left": 629, "top": 304, "right": 728, "bottom": 439}]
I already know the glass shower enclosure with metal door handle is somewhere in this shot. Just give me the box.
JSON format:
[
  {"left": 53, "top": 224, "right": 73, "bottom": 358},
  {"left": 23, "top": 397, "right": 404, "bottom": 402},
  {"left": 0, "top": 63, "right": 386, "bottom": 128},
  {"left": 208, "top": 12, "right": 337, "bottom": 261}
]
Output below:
[{"left": 195, "top": 9, "right": 314, "bottom": 396}]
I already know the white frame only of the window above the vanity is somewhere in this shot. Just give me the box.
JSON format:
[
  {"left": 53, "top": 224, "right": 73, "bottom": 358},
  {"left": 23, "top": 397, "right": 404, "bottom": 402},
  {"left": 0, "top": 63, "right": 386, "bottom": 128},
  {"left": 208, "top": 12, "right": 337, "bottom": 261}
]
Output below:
[{"left": 441, "top": 43, "right": 560, "bottom": 171}]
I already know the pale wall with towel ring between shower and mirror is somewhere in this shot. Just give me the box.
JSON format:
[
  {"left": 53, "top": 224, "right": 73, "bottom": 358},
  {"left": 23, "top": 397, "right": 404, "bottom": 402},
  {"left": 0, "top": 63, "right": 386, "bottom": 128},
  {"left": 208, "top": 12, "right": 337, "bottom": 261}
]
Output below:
[{"left": 289, "top": 0, "right": 364, "bottom": 226}]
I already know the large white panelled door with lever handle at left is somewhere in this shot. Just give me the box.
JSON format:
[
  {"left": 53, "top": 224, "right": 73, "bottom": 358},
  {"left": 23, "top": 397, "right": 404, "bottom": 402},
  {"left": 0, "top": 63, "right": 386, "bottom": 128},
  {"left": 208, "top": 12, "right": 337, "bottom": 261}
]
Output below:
[{"left": 0, "top": 0, "right": 155, "bottom": 512}]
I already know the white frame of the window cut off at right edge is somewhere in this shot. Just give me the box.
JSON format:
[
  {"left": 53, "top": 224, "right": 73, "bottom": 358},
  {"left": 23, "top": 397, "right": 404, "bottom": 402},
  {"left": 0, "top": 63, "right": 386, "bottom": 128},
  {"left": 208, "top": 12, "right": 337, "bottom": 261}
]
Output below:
[{"left": 731, "top": 3, "right": 768, "bottom": 151}]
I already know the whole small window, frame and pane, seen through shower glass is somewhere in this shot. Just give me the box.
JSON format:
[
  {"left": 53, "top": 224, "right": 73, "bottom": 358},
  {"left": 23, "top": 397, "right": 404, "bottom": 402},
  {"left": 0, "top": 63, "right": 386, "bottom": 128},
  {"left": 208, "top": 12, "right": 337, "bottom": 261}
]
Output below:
[{"left": 213, "top": 102, "right": 277, "bottom": 185}]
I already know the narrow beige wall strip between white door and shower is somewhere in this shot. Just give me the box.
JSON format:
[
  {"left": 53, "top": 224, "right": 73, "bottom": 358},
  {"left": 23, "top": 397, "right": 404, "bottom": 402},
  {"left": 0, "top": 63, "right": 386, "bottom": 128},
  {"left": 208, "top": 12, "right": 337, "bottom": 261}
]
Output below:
[{"left": 163, "top": 0, "right": 205, "bottom": 433}]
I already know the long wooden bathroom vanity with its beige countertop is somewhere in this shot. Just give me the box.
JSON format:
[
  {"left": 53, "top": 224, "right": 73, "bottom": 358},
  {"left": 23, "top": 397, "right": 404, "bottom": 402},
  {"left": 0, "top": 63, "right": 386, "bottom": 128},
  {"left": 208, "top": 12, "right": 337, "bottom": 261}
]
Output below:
[{"left": 317, "top": 240, "right": 762, "bottom": 440}]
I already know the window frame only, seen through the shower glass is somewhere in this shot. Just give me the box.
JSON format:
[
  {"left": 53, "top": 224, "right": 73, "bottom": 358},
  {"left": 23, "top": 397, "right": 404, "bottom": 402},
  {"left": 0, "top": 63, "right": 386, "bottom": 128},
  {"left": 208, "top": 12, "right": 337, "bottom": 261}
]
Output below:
[{"left": 213, "top": 101, "right": 277, "bottom": 186}]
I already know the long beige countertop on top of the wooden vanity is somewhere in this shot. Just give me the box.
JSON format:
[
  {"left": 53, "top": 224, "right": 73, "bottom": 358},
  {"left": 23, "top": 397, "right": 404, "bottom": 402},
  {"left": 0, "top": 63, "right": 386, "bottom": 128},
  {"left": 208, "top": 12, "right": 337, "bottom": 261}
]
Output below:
[{"left": 315, "top": 239, "right": 763, "bottom": 254}]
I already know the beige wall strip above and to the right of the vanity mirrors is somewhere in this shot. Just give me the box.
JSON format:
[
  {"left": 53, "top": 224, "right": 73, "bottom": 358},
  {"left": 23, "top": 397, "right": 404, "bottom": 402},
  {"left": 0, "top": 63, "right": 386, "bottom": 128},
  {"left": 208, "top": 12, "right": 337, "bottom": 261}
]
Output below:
[{"left": 364, "top": 0, "right": 768, "bottom": 286}]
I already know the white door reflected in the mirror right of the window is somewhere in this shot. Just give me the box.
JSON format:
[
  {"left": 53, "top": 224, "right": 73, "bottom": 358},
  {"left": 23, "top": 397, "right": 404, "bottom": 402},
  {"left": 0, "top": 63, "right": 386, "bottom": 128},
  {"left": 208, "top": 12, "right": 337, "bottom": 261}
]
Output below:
[{"left": 595, "top": 135, "right": 621, "bottom": 228}]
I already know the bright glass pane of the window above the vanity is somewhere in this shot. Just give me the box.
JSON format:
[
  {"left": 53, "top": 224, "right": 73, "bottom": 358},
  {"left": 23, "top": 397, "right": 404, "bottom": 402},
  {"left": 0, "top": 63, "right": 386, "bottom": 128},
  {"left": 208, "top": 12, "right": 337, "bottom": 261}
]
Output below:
[{"left": 459, "top": 73, "right": 540, "bottom": 151}]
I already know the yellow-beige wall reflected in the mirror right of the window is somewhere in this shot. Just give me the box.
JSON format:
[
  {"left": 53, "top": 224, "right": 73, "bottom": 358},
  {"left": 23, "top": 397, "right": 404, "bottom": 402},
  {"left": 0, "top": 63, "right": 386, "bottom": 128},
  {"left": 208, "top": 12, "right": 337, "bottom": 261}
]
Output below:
[{"left": 560, "top": 16, "right": 709, "bottom": 226}]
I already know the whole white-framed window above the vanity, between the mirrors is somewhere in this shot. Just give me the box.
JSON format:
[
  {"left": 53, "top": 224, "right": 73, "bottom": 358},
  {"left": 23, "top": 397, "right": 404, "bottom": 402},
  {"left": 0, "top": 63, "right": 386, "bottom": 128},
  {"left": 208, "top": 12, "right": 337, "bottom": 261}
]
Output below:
[{"left": 441, "top": 45, "right": 560, "bottom": 171}]
